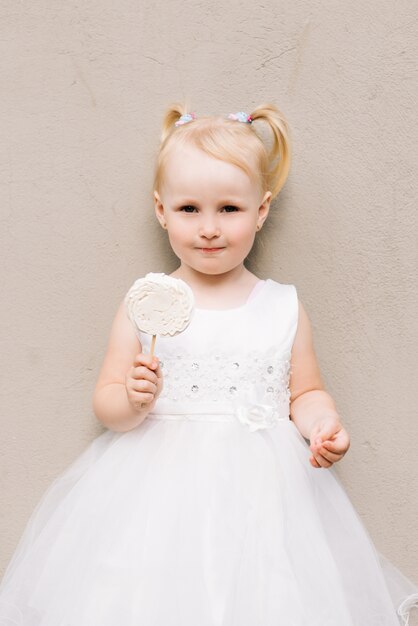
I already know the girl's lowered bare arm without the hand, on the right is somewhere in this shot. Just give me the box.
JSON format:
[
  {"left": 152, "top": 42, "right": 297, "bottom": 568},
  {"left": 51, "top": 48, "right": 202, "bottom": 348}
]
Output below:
[{"left": 289, "top": 301, "right": 338, "bottom": 439}]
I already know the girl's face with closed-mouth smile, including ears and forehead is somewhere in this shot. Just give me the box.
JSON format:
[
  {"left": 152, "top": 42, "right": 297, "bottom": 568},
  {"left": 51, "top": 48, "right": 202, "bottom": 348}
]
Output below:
[{"left": 154, "top": 145, "right": 271, "bottom": 274}]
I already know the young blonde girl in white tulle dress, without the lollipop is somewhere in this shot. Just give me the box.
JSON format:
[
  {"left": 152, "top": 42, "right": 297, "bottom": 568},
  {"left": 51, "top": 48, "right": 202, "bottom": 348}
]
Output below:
[{"left": 0, "top": 105, "right": 418, "bottom": 626}]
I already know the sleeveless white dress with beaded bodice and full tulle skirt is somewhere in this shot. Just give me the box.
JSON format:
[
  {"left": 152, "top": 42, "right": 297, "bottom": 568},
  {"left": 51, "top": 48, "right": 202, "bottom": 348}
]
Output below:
[{"left": 0, "top": 279, "right": 418, "bottom": 626}]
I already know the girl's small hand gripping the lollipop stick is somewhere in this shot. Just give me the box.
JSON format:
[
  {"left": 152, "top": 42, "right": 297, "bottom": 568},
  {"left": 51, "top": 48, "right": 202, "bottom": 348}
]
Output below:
[{"left": 125, "top": 352, "right": 163, "bottom": 411}]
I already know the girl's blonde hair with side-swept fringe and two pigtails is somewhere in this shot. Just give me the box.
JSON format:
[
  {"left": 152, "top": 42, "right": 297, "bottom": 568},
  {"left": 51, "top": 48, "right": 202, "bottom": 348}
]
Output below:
[{"left": 154, "top": 104, "right": 291, "bottom": 198}]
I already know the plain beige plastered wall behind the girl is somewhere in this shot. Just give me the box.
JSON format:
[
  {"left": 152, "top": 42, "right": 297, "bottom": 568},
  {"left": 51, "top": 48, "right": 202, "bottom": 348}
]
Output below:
[{"left": 0, "top": 0, "right": 418, "bottom": 582}]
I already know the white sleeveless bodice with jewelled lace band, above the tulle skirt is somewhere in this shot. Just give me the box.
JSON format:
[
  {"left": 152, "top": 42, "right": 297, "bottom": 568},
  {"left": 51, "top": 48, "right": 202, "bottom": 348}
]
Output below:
[{"left": 137, "top": 278, "right": 298, "bottom": 418}]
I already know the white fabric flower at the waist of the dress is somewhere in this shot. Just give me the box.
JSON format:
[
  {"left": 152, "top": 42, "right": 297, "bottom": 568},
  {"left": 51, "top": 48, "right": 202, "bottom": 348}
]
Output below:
[{"left": 233, "top": 384, "right": 289, "bottom": 432}]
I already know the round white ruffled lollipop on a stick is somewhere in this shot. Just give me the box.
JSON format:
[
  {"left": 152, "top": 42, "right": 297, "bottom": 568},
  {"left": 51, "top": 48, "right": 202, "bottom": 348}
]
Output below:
[{"left": 125, "top": 272, "right": 195, "bottom": 356}]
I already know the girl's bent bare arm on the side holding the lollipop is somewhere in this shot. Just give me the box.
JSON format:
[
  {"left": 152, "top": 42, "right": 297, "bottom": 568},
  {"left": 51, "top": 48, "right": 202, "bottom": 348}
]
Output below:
[{"left": 93, "top": 301, "right": 161, "bottom": 432}]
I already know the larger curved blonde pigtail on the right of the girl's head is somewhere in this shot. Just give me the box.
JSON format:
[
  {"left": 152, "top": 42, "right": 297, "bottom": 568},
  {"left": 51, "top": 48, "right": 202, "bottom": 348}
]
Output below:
[{"left": 250, "top": 104, "right": 291, "bottom": 198}]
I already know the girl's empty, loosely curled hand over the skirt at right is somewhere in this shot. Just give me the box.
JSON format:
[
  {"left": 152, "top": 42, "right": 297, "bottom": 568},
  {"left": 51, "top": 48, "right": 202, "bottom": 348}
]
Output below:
[{"left": 309, "top": 416, "right": 350, "bottom": 467}]
